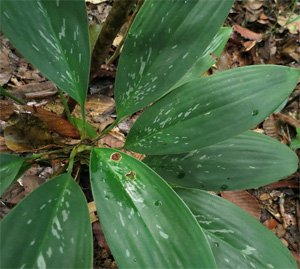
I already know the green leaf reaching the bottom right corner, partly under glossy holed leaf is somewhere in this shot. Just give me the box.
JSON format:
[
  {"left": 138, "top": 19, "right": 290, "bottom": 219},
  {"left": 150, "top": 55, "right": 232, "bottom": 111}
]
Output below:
[{"left": 176, "top": 188, "right": 297, "bottom": 269}]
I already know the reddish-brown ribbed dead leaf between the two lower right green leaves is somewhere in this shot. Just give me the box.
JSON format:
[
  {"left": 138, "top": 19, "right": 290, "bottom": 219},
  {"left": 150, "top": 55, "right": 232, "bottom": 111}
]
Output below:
[{"left": 221, "top": 190, "right": 261, "bottom": 220}]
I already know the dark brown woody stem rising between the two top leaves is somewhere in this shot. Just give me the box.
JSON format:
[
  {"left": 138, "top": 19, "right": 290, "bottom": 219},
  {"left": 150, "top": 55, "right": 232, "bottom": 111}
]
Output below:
[{"left": 91, "top": 0, "right": 137, "bottom": 79}]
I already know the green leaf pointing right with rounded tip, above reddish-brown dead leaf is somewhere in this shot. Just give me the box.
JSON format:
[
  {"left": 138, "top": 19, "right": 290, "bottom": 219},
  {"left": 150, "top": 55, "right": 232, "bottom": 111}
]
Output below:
[{"left": 143, "top": 131, "right": 298, "bottom": 191}]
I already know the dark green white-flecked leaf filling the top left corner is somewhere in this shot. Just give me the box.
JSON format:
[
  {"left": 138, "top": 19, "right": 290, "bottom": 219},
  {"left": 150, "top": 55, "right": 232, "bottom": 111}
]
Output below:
[{"left": 1, "top": 0, "right": 90, "bottom": 106}]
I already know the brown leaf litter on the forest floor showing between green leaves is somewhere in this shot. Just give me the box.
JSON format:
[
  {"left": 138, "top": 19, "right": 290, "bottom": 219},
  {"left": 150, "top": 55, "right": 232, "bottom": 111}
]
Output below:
[{"left": 0, "top": 0, "right": 300, "bottom": 268}]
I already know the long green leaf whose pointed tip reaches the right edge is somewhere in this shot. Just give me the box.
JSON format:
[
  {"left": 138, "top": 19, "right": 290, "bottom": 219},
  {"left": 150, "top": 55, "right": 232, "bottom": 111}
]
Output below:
[{"left": 125, "top": 65, "right": 300, "bottom": 155}]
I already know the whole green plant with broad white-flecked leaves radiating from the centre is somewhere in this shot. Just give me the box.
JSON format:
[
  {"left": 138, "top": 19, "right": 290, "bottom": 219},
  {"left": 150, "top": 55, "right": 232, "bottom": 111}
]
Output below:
[{"left": 0, "top": 0, "right": 300, "bottom": 269}]
